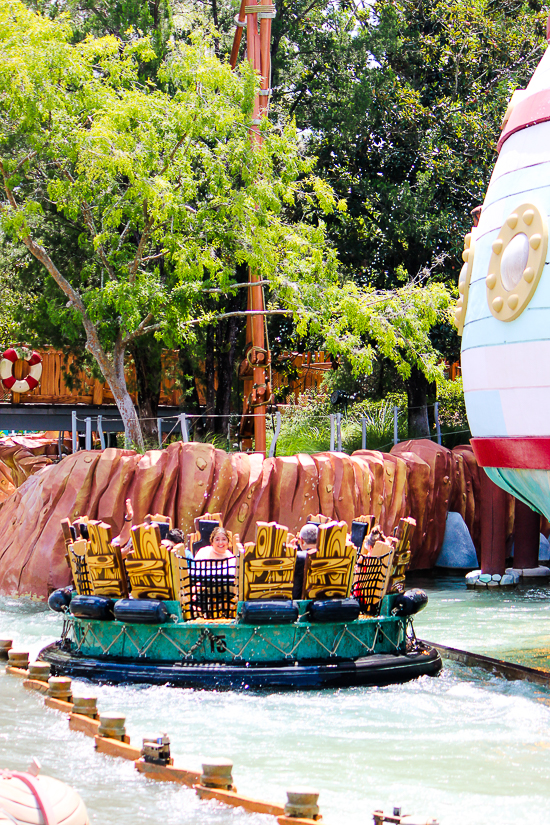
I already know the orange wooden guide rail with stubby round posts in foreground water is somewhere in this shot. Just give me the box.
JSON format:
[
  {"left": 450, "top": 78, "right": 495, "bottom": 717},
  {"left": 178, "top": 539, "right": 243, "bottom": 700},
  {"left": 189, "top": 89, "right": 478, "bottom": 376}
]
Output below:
[{"left": 0, "top": 652, "right": 322, "bottom": 825}]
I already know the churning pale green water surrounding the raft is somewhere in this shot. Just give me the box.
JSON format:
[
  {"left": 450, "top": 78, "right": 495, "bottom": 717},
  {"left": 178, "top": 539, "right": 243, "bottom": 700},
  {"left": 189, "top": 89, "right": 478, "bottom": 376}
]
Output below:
[{"left": 0, "top": 579, "right": 550, "bottom": 825}]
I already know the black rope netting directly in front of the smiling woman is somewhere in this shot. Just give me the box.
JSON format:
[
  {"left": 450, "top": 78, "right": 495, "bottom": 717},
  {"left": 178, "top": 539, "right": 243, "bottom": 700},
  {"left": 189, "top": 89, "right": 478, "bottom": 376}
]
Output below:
[{"left": 182, "top": 558, "right": 237, "bottom": 619}]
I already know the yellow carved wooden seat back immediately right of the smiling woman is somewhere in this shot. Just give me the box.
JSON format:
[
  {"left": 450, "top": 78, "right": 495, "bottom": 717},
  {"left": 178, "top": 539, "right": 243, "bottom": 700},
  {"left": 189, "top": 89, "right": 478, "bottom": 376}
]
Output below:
[{"left": 238, "top": 521, "right": 296, "bottom": 602}]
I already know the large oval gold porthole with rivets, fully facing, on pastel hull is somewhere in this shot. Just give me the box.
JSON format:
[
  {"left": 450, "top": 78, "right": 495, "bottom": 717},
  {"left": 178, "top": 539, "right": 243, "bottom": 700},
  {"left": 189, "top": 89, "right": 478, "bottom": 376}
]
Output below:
[{"left": 486, "top": 203, "right": 548, "bottom": 321}]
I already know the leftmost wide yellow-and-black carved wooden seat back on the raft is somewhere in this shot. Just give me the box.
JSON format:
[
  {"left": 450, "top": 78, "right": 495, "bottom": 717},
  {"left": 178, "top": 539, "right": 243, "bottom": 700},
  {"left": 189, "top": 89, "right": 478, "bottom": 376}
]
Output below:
[{"left": 86, "top": 521, "right": 128, "bottom": 599}]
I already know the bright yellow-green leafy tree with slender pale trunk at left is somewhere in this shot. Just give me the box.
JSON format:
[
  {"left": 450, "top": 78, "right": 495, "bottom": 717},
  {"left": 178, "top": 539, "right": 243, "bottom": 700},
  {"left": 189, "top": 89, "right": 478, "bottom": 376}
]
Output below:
[{"left": 0, "top": 0, "right": 335, "bottom": 446}]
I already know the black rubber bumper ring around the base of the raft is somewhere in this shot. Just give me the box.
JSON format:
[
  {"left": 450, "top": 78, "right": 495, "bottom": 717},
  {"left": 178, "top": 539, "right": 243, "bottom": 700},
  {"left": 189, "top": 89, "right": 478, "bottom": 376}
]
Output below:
[{"left": 40, "top": 642, "right": 441, "bottom": 690}]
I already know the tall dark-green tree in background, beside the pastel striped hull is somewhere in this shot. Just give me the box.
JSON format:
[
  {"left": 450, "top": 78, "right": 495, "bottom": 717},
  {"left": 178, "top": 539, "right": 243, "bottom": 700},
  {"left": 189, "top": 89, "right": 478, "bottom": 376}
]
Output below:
[{"left": 266, "top": 0, "right": 546, "bottom": 434}]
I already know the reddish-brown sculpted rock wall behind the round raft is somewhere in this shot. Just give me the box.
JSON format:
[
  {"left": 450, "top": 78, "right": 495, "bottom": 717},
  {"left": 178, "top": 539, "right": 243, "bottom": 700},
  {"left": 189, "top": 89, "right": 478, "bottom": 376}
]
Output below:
[{"left": 0, "top": 440, "right": 506, "bottom": 597}]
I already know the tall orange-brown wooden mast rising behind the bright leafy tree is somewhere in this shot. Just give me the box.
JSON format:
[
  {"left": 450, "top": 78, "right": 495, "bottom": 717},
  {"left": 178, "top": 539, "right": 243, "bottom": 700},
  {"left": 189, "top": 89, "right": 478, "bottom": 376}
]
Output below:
[{"left": 230, "top": 0, "right": 275, "bottom": 454}]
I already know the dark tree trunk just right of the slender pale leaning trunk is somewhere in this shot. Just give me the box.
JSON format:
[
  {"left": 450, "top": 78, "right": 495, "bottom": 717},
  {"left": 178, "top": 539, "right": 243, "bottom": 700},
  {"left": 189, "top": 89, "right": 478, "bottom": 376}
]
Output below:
[{"left": 130, "top": 333, "right": 162, "bottom": 447}]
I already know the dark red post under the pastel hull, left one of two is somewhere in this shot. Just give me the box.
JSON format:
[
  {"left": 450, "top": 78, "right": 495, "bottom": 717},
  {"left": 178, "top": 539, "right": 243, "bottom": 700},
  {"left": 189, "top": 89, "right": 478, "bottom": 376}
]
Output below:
[{"left": 480, "top": 471, "right": 506, "bottom": 575}]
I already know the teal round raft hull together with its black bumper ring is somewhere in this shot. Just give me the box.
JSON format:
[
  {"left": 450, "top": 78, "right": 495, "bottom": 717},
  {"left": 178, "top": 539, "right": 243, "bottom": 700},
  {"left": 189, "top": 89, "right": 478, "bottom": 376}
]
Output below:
[{"left": 40, "top": 597, "right": 441, "bottom": 689}]
